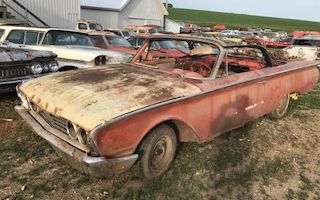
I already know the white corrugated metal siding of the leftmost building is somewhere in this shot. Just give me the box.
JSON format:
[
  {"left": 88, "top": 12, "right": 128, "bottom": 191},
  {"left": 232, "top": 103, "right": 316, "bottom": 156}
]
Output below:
[{"left": 7, "top": 0, "right": 80, "bottom": 29}]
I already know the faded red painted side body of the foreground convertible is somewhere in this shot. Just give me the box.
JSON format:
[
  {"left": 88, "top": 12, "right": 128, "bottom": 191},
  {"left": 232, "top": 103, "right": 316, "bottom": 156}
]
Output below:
[{"left": 95, "top": 62, "right": 319, "bottom": 157}]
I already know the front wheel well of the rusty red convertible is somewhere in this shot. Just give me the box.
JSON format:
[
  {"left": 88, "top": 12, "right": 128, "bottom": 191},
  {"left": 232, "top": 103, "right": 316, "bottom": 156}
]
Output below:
[{"left": 135, "top": 120, "right": 198, "bottom": 153}]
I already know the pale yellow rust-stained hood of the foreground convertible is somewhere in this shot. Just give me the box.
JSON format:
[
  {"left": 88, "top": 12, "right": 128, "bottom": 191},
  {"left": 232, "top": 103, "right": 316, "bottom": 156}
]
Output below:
[{"left": 19, "top": 64, "right": 201, "bottom": 131}]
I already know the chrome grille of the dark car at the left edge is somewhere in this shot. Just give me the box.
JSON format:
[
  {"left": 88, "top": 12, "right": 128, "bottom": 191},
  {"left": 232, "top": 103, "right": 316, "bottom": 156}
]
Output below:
[{"left": 0, "top": 65, "right": 32, "bottom": 79}]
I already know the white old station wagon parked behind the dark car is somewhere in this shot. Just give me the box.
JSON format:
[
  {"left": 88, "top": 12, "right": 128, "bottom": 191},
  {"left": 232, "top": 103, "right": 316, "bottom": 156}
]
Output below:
[{"left": 0, "top": 26, "right": 131, "bottom": 71}]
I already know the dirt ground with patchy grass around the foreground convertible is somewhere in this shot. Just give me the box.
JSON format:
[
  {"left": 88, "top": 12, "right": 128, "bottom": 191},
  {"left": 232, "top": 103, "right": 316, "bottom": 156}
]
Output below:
[{"left": 0, "top": 81, "right": 320, "bottom": 200}]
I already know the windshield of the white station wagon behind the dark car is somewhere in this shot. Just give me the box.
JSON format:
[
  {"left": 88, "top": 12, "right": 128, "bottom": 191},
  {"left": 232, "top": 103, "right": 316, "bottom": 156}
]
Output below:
[{"left": 43, "top": 30, "right": 93, "bottom": 46}]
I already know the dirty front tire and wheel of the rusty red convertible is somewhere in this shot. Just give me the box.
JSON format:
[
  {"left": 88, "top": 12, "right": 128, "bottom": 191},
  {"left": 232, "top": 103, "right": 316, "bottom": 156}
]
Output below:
[{"left": 138, "top": 124, "right": 177, "bottom": 180}]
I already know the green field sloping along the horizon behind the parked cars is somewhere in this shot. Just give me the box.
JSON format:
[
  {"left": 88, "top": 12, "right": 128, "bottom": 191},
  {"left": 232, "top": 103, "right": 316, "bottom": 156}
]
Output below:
[{"left": 169, "top": 8, "right": 320, "bottom": 31}]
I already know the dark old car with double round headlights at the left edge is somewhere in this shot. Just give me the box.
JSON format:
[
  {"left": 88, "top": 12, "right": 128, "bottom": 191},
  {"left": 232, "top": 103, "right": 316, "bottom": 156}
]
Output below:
[{"left": 0, "top": 47, "right": 59, "bottom": 94}]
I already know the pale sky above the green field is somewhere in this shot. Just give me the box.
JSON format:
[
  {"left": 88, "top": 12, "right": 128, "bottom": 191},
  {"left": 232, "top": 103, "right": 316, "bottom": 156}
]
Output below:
[{"left": 163, "top": 0, "right": 320, "bottom": 22}]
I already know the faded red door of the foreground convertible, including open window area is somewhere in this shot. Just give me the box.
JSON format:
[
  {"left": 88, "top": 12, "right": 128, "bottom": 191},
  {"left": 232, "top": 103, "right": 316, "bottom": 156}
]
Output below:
[{"left": 212, "top": 46, "right": 267, "bottom": 133}]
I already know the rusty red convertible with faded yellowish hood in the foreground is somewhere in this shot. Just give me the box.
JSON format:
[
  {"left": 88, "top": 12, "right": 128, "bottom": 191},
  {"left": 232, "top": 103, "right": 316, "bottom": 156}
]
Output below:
[{"left": 15, "top": 35, "right": 319, "bottom": 179}]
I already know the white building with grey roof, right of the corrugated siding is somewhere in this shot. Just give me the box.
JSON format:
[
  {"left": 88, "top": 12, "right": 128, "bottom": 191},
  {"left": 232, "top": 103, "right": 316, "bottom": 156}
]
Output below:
[{"left": 81, "top": 0, "right": 168, "bottom": 28}]
